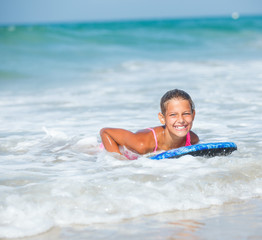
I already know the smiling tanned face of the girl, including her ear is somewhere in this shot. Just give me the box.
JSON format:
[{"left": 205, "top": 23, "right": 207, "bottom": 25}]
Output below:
[{"left": 159, "top": 98, "right": 195, "bottom": 137}]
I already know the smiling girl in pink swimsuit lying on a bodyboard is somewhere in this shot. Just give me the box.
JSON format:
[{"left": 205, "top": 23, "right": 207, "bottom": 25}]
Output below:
[{"left": 100, "top": 89, "right": 199, "bottom": 159}]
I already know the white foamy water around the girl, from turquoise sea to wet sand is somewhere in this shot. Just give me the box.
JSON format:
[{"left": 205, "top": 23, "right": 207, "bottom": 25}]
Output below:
[{"left": 0, "top": 16, "right": 262, "bottom": 238}]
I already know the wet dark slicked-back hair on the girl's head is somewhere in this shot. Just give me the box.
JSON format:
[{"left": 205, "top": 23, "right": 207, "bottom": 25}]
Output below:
[{"left": 160, "top": 89, "right": 195, "bottom": 116}]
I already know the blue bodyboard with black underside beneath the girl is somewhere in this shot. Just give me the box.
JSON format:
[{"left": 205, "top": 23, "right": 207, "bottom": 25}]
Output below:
[{"left": 150, "top": 142, "right": 237, "bottom": 160}]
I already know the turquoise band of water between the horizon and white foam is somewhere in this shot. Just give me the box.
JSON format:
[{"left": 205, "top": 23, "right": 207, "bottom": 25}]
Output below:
[{"left": 0, "top": 17, "right": 262, "bottom": 91}]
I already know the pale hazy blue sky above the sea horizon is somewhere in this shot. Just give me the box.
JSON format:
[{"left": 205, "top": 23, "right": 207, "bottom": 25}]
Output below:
[{"left": 0, "top": 0, "right": 262, "bottom": 24}]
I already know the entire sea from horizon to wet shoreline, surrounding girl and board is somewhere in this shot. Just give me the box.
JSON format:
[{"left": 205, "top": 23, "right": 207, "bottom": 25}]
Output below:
[{"left": 0, "top": 17, "right": 262, "bottom": 239}]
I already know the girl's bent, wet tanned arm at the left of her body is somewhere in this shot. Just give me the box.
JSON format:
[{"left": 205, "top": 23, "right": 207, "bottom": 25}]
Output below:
[{"left": 100, "top": 128, "right": 146, "bottom": 154}]
